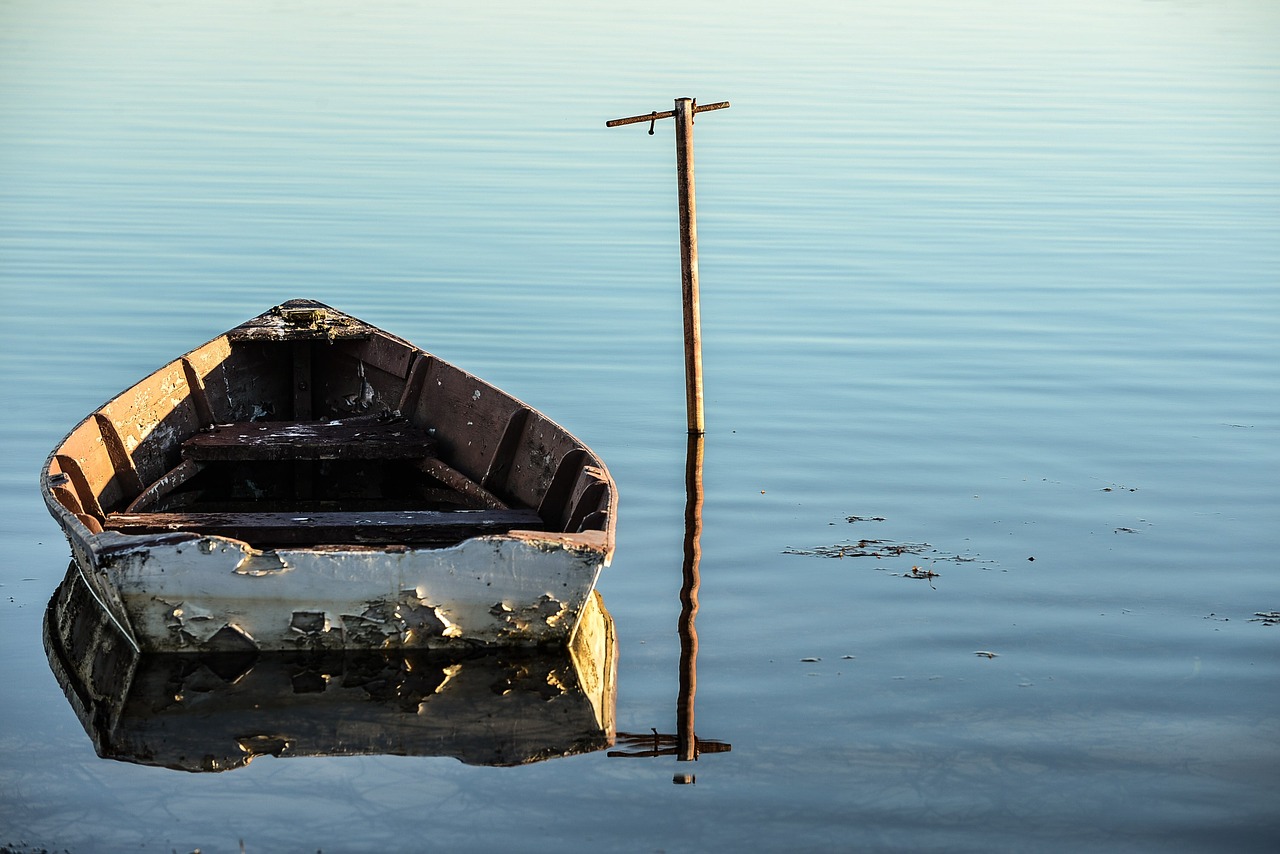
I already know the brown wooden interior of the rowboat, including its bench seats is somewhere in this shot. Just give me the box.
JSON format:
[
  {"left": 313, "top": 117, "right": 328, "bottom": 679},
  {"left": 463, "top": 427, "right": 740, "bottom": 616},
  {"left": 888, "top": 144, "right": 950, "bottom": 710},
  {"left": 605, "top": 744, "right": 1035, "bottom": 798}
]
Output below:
[{"left": 47, "top": 300, "right": 614, "bottom": 548}]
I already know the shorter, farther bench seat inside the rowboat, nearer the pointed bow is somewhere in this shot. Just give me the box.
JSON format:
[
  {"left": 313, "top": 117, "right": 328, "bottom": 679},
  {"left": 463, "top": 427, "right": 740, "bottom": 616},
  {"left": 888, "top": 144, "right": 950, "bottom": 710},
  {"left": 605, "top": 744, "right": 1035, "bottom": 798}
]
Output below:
[{"left": 182, "top": 419, "right": 435, "bottom": 461}]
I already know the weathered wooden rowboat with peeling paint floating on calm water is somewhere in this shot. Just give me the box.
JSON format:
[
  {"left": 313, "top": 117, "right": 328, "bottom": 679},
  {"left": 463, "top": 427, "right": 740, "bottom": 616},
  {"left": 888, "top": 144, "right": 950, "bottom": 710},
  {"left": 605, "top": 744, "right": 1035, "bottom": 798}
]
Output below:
[{"left": 42, "top": 300, "right": 617, "bottom": 652}]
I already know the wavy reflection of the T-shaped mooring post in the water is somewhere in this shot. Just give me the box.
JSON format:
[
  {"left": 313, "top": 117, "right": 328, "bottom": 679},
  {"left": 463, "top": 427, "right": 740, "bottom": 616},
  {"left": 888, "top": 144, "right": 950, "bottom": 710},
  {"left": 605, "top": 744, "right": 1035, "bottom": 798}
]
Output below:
[{"left": 608, "top": 433, "right": 732, "bottom": 785}]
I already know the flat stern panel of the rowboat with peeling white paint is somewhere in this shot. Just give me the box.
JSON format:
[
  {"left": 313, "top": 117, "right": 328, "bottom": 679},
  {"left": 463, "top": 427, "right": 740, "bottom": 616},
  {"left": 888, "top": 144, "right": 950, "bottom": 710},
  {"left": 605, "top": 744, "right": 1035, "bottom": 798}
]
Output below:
[{"left": 87, "top": 533, "right": 603, "bottom": 650}]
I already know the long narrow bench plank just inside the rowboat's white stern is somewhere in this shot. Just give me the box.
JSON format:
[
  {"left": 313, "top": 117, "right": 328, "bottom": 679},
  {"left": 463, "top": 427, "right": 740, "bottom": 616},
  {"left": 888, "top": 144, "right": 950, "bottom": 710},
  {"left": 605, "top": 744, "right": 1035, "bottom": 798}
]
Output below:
[{"left": 104, "top": 510, "right": 544, "bottom": 545}]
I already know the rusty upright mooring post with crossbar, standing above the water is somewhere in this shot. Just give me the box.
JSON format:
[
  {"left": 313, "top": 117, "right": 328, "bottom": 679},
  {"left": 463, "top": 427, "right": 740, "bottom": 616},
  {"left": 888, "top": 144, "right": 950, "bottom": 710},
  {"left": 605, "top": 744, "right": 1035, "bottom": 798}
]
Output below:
[{"left": 604, "top": 97, "right": 728, "bottom": 435}]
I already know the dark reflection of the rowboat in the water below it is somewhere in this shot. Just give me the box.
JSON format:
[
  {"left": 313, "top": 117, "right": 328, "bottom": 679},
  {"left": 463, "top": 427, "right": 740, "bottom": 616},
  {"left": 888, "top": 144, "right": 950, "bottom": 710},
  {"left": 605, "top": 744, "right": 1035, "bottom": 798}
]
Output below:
[{"left": 45, "top": 563, "right": 617, "bottom": 771}]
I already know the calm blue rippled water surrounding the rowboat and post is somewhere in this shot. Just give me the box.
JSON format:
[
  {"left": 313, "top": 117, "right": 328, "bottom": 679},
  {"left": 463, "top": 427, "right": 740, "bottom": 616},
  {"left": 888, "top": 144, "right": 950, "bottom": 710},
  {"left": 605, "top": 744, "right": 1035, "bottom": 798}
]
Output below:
[{"left": 0, "top": 0, "right": 1280, "bottom": 851}]
